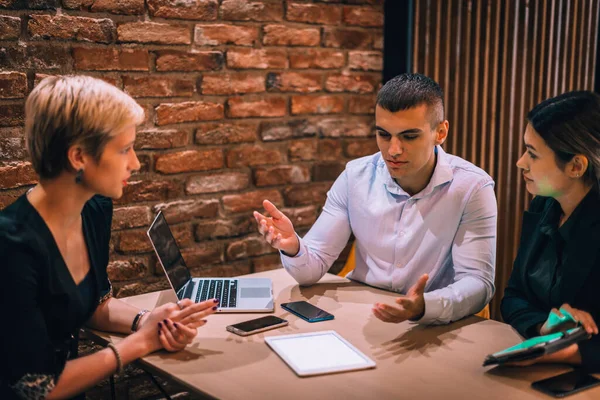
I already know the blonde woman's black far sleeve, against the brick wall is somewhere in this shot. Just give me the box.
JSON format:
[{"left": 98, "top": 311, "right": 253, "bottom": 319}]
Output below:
[{"left": 89, "top": 195, "right": 113, "bottom": 304}]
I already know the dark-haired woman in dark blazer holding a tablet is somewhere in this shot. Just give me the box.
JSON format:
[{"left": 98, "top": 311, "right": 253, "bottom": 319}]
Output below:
[{"left": 502, "top": 92, "right": 600, "bottom": 371}]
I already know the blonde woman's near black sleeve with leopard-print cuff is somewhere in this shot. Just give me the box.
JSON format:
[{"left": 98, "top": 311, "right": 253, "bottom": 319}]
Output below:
[{"left": 0, "top": 223, "right": 66, "bottom": 398}]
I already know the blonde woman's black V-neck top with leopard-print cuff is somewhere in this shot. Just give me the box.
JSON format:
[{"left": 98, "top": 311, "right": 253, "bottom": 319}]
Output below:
[{"left": 0, "top": 195, "right": 112, "bottom": 398}]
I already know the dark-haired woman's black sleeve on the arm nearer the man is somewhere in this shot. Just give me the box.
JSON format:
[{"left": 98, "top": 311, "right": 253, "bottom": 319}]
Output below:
[{"left": 500, "top": 197, "right": 549, "bottom": 338}]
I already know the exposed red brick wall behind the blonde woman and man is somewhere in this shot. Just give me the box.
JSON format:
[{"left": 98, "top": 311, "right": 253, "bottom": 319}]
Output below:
[{"left": 0, "top": 0, "right": 383, "bottom": 396}]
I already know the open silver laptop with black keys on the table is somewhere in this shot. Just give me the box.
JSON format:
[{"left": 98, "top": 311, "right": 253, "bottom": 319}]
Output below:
[{"left": 148, "top": 211, "right": 274, "bottom": 312}]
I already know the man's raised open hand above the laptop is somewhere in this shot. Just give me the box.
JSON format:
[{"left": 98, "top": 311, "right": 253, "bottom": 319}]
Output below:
[{"left": 254, "top": 200, "right": 300, "bottom": 257}]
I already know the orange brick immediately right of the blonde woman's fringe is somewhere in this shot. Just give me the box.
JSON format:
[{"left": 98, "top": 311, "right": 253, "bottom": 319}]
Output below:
[{"left": 156, "top": 101, "right": 224, "bottom": 125}]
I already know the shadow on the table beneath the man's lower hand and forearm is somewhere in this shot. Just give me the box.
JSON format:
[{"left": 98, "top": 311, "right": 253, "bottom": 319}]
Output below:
[{"left": 363, "top": 316, "right": 481, "bottom": 363}]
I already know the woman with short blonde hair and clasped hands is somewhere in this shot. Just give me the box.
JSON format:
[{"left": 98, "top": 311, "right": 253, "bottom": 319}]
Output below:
[{"left": 0, "top": 76, "right": 216, "bottom": 399}]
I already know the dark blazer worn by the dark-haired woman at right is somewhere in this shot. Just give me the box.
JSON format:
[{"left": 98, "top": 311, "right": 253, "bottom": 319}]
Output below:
[{"left": 501, "top": 190, "right": 600, "bottom": 371}]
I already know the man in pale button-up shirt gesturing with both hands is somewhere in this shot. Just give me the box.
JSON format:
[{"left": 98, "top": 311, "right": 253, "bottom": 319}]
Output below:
[{"left": 254, "top": 74, "right": 497, "bottom": 324}]
